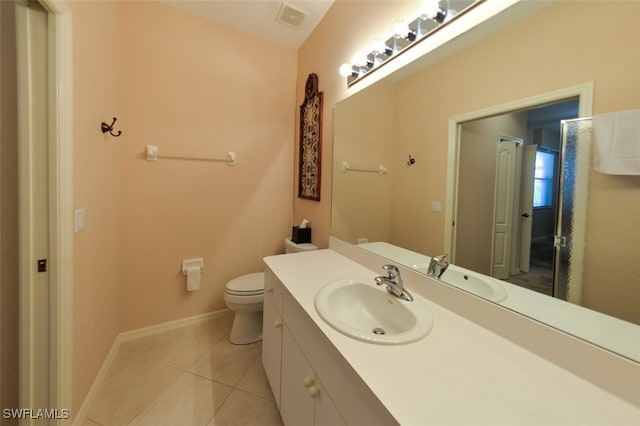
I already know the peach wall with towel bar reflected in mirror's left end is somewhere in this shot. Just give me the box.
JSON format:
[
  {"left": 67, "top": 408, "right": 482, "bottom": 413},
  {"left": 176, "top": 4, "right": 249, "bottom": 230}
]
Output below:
[{"left": 331, "top": 83, "right": 395, "bottom": 243}]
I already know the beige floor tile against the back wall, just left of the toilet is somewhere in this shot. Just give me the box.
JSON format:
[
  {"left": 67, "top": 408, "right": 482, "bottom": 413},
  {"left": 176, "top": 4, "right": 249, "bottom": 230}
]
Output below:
[{"left": 121, "top": 315, "right": 233, "bottom": 369}]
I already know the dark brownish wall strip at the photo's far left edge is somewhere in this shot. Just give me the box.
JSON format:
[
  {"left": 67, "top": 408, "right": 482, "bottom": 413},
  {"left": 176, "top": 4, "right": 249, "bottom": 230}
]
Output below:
[{"left": 0, "top": 2, "right": 18, "bottom": 414}]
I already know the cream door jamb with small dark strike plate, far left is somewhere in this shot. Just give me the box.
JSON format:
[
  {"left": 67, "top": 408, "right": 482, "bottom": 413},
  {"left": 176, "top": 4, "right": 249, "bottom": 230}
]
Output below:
[{"left": 16, "top": 2, "right": 51, "bottom": 408}]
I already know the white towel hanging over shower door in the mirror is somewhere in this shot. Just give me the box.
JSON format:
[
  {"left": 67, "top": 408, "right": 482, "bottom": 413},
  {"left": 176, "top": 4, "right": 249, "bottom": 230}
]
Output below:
[{"left": 593, "top": 109, "right": 640, "bottom": 175}]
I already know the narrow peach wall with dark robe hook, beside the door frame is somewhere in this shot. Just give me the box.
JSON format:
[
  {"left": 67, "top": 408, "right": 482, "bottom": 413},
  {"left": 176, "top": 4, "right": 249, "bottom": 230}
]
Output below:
[{"left": 69, "top": 1, "right": 122, "bottom": 412}]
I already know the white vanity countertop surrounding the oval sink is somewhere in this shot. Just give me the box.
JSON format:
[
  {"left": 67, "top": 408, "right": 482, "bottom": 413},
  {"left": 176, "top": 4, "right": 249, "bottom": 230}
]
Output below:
[{"left": 265, "top": 250, "right": 640, "bottom": 426}]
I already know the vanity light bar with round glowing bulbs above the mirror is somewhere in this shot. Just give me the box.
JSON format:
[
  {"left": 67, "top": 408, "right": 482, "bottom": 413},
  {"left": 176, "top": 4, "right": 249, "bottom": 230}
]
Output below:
[{"left": 339, "top": 0, "right": 484, "bottom": 86}]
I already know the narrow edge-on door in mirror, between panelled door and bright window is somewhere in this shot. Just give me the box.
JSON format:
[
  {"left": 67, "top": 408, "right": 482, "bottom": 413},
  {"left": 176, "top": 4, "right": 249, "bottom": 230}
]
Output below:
[{"left": 520, "top": 145, "right": 537, "bottom": 272}]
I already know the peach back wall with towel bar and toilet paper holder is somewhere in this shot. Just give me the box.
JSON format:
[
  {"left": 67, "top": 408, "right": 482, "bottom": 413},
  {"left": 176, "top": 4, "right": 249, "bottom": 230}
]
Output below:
[{"left": 119, "top": 2, "right": 296, "bottom": 331}]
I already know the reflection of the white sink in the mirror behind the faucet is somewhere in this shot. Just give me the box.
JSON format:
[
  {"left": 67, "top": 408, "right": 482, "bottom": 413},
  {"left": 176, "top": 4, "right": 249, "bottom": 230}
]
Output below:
[{"left": 411, "top": 263, "right": 507, "bottom": 302}]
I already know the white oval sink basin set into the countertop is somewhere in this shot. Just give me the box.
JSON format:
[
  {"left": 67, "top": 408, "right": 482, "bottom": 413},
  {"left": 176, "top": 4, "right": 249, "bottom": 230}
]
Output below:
[{"left": 315, "top": 279, "right": 433, "bottom": 345}]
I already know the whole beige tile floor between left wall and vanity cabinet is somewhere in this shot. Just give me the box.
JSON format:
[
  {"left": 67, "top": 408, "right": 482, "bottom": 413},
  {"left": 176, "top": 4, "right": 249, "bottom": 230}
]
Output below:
[{"left": 83, "top": 314, "right": 282, "bottom": 426}]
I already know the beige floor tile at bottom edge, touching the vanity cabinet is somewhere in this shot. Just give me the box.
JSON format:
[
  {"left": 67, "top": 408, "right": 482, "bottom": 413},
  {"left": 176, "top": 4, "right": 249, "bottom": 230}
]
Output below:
[{"left": 208, "top": 389, "right": 283, "bottom": 426}]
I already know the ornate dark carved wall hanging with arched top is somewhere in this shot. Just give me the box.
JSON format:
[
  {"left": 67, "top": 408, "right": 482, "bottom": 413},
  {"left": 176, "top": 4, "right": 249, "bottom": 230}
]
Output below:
[{"left": 298, "top": 74, "right": 322, "bottom": 201}]
